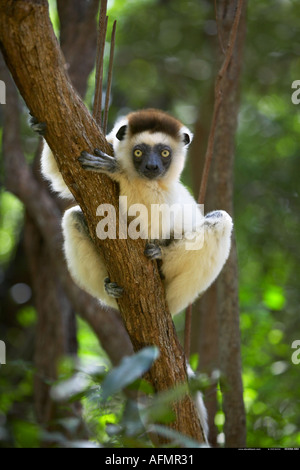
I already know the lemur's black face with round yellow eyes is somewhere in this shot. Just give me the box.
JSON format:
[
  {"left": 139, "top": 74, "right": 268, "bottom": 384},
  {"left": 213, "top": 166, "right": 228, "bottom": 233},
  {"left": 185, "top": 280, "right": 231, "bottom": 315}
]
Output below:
[{"left": 132, "top": 144, "right": 172, "bottom": 180}]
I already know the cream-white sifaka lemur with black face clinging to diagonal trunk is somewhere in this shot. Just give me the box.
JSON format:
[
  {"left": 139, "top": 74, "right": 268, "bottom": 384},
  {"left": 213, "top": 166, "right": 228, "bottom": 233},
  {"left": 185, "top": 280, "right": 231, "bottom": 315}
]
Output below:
[{"left": 37, "top": 109, "right": 232, "bottom": 315}]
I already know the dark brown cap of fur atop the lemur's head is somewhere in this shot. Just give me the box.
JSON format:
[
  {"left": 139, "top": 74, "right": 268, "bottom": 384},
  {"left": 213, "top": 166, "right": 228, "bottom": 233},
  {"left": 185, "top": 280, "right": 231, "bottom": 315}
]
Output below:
[{"left": 127, "top": 109, "right": 182, "bottom": 139}]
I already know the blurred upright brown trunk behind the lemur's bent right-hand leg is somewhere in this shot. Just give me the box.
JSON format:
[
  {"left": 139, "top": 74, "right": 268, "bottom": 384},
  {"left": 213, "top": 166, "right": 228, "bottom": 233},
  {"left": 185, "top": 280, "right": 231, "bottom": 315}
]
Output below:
[{"left": 192, "top": 0, "right": 246, "bottom": 447}]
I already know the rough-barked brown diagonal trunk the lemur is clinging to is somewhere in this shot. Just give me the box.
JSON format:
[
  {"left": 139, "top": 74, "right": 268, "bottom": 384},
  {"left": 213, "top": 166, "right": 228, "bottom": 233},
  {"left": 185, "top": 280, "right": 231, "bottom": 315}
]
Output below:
[{"left": 0, "top": 0, "right": 204, "bottom": 442}]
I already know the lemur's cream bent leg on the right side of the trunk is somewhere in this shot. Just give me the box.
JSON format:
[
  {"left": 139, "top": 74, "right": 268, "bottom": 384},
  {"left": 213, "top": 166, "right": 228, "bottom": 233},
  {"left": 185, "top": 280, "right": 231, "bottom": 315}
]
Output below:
[{"left": 162, "top": 211, "right": 232, "bottom": 315}]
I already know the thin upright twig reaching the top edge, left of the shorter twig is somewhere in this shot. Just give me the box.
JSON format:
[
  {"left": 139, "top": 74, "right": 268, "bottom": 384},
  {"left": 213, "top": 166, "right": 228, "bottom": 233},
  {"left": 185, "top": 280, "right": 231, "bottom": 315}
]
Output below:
[{"left": 93, "top": 0, "right": 108, "bottom": 126}]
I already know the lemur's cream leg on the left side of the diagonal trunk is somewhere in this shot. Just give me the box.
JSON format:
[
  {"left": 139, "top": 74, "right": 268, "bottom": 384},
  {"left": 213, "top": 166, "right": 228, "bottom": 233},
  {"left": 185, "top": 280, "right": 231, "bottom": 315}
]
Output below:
[{"left": 62, "top": 206, "right": 123, "bottom": 309}]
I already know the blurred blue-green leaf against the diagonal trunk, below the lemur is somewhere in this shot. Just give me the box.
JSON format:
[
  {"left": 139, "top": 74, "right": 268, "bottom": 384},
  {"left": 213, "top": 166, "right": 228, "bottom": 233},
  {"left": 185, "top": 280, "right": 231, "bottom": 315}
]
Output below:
[{"left": 102, "top": 346, "right": 159, "bottom": 400}]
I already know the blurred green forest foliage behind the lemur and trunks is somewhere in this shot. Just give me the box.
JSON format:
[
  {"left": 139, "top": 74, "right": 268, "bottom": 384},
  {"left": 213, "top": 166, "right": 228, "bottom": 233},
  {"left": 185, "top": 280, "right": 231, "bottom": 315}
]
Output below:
[{"left": 0, "top": 0, "right": 300, "bottom": 447}]
